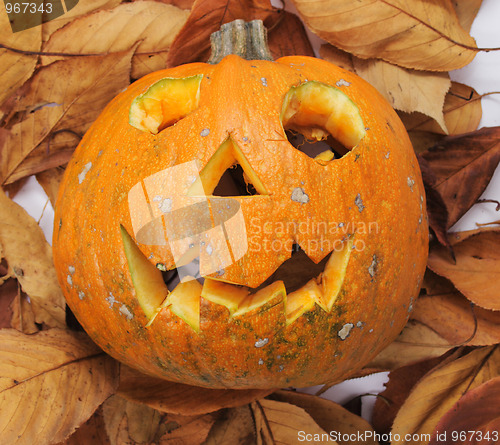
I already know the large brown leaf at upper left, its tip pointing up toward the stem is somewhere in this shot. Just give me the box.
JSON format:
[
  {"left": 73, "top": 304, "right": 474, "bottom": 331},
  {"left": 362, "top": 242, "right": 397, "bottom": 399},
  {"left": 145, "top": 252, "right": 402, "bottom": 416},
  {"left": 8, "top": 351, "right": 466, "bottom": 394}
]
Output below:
[{"left": 0, "top": 49, "right": 133, "bottom": 184}]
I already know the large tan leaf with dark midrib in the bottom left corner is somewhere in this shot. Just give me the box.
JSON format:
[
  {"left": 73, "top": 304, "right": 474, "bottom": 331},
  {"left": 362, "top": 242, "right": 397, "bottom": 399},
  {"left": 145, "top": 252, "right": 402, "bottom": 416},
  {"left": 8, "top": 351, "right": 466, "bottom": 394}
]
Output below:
[{"left": 0, "top": 329, "right": 118, "bottom": 445}]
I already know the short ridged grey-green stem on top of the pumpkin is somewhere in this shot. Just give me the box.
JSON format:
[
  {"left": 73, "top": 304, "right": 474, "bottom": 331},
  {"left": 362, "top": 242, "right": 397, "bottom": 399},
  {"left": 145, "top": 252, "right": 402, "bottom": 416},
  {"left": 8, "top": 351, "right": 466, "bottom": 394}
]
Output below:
[{"left": 208, "top": 19, "right": 273, "bottom": 64}]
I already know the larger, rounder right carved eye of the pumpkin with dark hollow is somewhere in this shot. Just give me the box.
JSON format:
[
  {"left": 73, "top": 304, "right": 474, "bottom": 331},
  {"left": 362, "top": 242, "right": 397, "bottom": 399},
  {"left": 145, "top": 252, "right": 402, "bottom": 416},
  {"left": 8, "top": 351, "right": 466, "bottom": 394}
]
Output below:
[{"left": 280, "top": 81, "right": 365, "bottom": 163}]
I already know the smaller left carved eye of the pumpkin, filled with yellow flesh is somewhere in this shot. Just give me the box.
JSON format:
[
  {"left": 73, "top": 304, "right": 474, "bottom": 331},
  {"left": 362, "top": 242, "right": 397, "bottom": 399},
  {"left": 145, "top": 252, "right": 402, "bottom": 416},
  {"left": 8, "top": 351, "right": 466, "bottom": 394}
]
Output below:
[{"left": 129, "top": 75, "right": 203, "bottom": 134}]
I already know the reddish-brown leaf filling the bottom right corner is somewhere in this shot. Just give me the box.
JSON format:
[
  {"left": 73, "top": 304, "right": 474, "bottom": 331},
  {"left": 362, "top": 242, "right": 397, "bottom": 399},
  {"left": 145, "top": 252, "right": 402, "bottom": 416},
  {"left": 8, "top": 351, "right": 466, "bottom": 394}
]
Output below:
[{"left": 429, "top": 377, "right": 500, "bottom": 445}]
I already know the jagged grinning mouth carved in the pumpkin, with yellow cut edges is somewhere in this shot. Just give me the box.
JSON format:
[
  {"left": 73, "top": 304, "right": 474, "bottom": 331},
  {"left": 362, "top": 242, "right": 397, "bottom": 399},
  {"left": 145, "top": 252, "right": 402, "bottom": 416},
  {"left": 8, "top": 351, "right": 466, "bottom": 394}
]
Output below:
[{"left": 121, "top": 227, "right": 353, "bottom": 332}]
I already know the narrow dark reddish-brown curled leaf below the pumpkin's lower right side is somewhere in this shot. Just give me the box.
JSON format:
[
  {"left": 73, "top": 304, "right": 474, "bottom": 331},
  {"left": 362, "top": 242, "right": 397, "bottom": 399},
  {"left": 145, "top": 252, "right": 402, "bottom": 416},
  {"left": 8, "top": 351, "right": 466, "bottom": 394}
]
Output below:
[{"left": 372, "top": 355, "right": 445, "bottom": 434}]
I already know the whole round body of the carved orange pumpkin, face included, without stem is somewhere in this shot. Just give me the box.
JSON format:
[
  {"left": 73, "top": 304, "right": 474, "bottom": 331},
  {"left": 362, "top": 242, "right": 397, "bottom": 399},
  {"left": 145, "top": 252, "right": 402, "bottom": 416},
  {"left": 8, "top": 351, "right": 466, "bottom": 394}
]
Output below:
[{"left": 53, "top": 24, "right": 428, "bottom": 388}]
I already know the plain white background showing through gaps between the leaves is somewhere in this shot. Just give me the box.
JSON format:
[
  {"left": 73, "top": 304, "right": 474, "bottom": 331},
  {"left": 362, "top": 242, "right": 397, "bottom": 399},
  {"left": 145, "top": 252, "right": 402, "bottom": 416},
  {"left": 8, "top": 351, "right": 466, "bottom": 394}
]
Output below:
[{"left": 14, "top": 0, "right": 500, "bottom": 418}]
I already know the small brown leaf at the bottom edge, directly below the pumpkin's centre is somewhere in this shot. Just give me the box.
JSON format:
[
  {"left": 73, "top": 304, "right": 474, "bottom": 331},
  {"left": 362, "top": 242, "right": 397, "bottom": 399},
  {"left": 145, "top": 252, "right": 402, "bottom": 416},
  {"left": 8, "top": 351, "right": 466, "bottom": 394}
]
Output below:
[{"left": 204, "top": 405, "right": 256, "bottom": 445}]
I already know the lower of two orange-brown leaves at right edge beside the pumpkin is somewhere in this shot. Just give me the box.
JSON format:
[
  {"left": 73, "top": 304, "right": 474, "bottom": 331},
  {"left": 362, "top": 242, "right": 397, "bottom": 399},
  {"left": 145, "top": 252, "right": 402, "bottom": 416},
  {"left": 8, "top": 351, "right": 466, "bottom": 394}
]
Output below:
[{"left": 411, "top": 274, "right": 500, "bottom": 346}]
